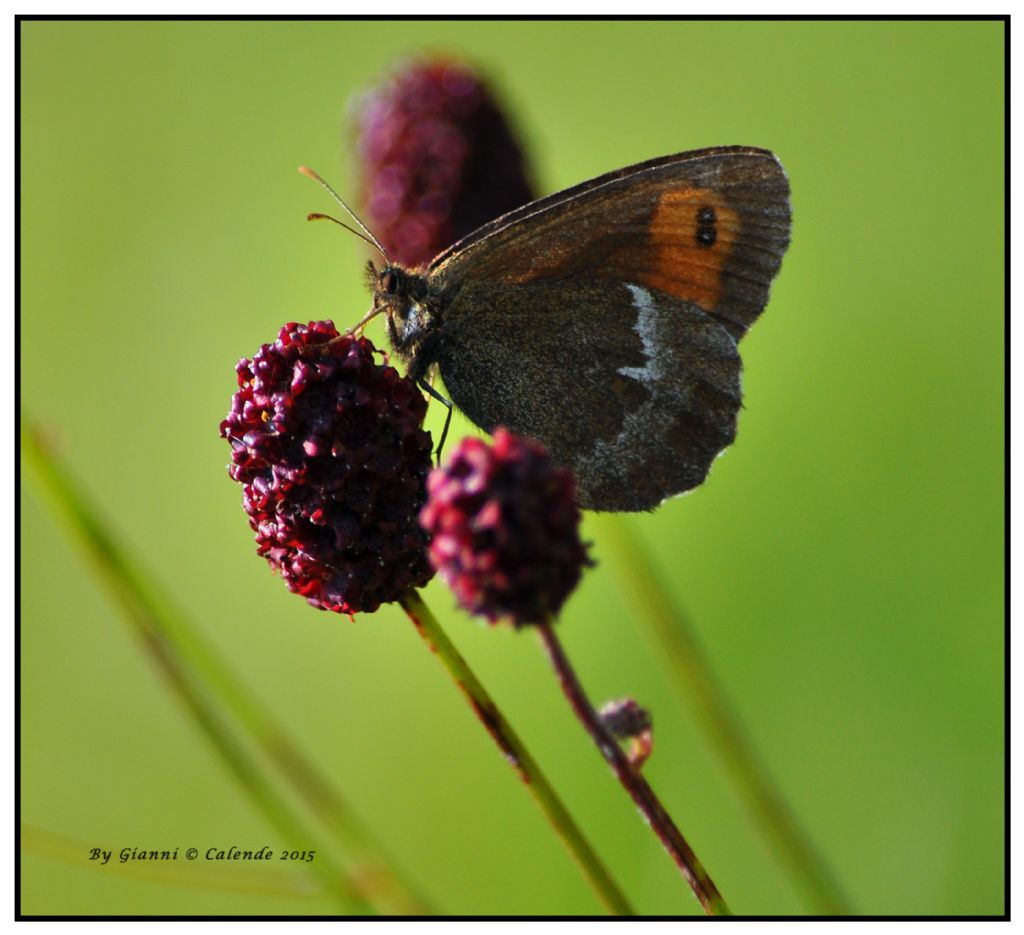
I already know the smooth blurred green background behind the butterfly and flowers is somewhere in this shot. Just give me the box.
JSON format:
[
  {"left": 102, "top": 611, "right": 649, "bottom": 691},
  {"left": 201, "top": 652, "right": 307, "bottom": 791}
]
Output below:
[{"left": 20, "top": 22, "right": 1005, "bottom": 913}]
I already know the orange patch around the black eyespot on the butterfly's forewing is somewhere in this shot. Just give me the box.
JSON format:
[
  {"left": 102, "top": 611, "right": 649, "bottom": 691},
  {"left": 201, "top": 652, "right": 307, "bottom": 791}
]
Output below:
[{"left": 642, "top": 188, "right": 739, "bottom": 311}]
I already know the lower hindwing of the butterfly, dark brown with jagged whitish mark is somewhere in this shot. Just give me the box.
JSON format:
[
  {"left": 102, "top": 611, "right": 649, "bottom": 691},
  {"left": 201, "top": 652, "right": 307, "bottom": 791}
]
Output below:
[{"left": 436, "top": 280, "right": 740, "bottom": 511}]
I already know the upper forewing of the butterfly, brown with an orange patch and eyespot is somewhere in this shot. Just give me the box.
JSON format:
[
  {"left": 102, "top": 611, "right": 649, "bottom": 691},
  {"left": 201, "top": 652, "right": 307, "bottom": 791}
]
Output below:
[{"left": 429, "top": 146, "right": 791, "bottom": 339}]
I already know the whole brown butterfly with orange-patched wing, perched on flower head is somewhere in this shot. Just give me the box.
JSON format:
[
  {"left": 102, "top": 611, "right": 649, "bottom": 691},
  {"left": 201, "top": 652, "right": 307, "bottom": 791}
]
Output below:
[{"left": 302, "top": 146, "right": 791, "bottom": 511}]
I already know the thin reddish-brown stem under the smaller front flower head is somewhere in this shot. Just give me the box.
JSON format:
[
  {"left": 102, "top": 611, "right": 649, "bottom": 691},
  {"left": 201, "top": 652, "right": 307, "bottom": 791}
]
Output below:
[{"left": 535, "top": 623, "right": 732, "bottom": 916}]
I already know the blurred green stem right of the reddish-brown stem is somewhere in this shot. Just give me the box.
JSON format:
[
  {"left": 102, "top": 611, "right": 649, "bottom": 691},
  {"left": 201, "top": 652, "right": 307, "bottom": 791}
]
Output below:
[{"left": 599, "top": 515, "right": 850, "bottom": 916}]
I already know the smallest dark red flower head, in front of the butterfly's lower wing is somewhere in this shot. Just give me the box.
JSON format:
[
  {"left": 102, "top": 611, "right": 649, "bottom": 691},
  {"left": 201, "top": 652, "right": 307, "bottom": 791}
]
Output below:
[{"left": 420, "top": 428, "right": 590, "bottom": 626}]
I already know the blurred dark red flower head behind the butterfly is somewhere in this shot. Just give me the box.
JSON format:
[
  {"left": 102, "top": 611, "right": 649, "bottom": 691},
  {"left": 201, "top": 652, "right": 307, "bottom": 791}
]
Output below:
[{"left": 353, "top": 59, "right": 534, "bottom": 267}]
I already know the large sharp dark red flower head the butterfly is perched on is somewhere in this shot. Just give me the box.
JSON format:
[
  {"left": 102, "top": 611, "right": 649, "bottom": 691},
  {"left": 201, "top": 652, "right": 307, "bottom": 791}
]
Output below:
[{"left": 220, "top": 322, "right": 433, "bottom": 613}]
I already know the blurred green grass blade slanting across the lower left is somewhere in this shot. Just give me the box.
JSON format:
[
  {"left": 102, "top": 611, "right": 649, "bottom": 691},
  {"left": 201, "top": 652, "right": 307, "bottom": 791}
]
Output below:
[{"left": 22, "top": 426, "right": 428, "bottom": 915}]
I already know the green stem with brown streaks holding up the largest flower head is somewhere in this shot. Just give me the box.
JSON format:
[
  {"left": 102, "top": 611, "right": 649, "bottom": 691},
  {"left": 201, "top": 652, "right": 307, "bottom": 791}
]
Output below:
[{"left": 400, "top": 590, "right": 633, "bottom": 916}]
